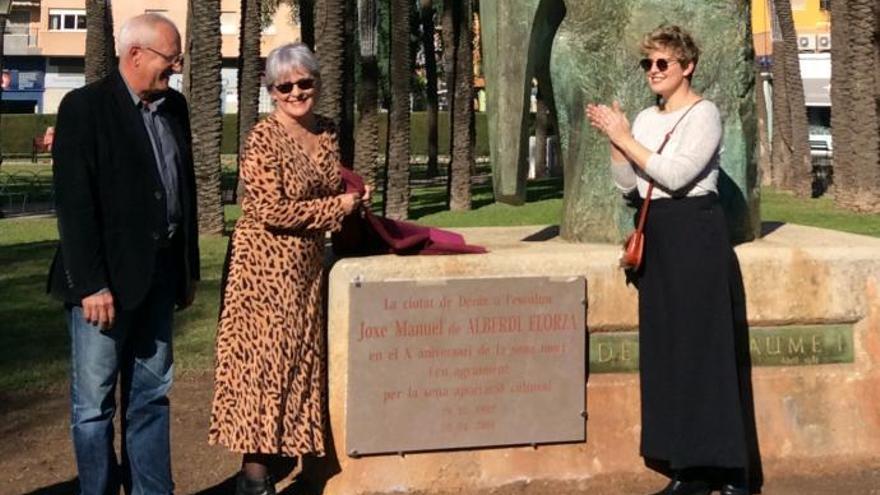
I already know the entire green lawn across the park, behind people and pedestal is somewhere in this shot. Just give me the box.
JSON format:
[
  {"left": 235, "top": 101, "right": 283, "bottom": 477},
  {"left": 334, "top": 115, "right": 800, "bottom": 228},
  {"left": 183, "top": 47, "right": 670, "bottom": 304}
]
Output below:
[{"left": 0, "top": 182, "right": 880, "bottom": 394}]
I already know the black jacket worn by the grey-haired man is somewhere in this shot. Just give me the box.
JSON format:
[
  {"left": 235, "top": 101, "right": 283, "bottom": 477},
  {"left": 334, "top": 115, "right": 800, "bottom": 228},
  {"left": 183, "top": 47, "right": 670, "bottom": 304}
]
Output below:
[{"left": 48, "top": 72, "right": 199, "bottom": 309}]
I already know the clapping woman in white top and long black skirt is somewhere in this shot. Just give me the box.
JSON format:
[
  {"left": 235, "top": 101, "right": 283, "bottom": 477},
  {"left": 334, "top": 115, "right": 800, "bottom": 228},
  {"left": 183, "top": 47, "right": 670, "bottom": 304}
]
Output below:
[{"left": 586, "top": 26, "right": 760, "bottom": 495}]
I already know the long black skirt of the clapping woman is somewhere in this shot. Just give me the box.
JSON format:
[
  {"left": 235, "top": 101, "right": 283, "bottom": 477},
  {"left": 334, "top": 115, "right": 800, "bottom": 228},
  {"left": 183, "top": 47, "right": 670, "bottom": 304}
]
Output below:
[{"left": 637, "top": 194, "right": 757, "bottom": 474}]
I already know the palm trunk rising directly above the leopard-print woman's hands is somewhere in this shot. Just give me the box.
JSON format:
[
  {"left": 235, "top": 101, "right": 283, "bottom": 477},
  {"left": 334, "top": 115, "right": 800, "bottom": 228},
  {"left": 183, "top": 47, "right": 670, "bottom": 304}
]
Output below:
[{"left": 354, "top": 0, "right": 379, "bottom": 185}]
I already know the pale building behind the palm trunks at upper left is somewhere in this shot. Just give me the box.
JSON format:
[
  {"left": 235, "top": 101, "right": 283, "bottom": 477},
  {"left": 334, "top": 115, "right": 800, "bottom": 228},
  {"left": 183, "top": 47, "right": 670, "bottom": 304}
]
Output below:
[{"left": 2, "top": 0, "right": 300, "bottom": 113}]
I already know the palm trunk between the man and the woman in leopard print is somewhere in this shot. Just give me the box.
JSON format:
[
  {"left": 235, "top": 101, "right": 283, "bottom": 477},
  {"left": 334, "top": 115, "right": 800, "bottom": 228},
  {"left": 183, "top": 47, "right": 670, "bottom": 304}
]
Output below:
[{"left": 184, "top": 0, "right": 223, "bottom": 234}]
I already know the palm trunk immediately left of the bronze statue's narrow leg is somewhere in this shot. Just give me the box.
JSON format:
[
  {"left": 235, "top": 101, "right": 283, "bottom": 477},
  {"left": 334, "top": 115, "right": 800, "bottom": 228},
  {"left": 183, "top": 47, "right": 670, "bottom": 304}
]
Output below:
[{"left": 448, "top": 0, "right": 474, "bottom": 211}]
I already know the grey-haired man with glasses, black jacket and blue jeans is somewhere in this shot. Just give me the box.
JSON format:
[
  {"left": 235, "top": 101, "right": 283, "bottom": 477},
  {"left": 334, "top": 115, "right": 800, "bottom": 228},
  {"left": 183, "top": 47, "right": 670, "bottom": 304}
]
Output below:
[{"left": 49, "top": 14, "right": 199, "bottom": 494}]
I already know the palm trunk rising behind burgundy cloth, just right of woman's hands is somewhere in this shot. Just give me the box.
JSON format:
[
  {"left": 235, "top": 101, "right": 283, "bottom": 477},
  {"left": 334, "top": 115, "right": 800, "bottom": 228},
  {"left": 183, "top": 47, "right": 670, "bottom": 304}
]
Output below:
[{"left": 384, "top": 0, "right": 412, "bottom": 220}]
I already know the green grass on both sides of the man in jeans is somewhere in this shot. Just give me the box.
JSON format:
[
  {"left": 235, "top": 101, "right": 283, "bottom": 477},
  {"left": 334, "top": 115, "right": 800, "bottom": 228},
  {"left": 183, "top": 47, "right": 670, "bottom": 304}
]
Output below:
[{"left": 0, "top": 218, "right": 226, "bottom": 394}]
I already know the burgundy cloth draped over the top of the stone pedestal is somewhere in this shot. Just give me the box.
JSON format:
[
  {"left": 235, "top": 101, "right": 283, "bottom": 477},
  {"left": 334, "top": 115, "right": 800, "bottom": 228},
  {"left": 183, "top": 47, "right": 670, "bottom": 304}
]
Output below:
[{"left": 333, "top": 168, "right": 486, "bottom": 256}]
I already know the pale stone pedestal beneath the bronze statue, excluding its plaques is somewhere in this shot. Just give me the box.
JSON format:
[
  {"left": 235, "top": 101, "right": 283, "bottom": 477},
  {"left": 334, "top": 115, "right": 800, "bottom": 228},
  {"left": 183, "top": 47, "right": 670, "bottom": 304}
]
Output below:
[{"left": 307, "top": 225, "right": 880, "bottom": 495}]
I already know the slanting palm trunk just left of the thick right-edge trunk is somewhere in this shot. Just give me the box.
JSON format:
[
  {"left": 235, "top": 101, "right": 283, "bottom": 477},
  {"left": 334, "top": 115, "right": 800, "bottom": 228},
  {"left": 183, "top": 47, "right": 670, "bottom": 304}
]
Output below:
[{"left": 771, "top": 0, "right": 813, "bottom": 196}]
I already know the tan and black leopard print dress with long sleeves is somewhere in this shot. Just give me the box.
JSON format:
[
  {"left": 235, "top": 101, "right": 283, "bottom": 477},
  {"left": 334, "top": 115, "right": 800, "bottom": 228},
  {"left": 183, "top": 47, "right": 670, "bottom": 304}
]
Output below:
[{"left": 209, "top": 115, "right": 344, "bottom": 457}]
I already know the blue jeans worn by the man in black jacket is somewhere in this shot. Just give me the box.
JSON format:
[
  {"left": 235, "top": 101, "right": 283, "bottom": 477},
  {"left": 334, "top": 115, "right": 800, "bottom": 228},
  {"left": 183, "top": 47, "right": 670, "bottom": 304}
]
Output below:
[{"left": 67, "top": 267, "right": 174, "bottom": 495}]
